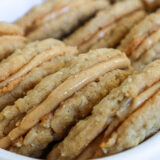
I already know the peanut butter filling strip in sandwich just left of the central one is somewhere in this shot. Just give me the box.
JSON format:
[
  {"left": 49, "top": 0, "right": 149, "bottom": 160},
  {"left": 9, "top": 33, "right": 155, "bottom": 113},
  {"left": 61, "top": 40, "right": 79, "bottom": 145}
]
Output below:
[{"left": 0, "top": 46, "right": 77, "bottom": 93}]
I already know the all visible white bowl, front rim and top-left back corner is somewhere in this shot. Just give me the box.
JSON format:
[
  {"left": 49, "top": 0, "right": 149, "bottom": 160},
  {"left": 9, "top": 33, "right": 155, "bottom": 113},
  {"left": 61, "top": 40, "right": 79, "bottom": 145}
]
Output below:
[{"left": 0, "top": 0, "right": 160, "bottom": 160}]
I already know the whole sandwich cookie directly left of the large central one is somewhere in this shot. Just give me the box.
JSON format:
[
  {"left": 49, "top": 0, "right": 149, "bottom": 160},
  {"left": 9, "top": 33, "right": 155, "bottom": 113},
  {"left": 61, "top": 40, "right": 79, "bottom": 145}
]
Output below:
[{"left": 0, "top": 39, "right": 78, "bottom": 110}]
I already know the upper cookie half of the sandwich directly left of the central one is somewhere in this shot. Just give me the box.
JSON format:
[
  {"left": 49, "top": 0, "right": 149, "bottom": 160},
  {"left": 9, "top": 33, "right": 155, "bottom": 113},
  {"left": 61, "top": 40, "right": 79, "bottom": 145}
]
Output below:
[{"left": 0, "top": 39, "right": 63, "bottom": 82}]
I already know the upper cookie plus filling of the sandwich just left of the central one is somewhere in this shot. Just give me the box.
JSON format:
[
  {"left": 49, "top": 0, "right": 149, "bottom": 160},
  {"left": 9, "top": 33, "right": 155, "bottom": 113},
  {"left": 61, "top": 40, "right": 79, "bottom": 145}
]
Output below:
[{"left": 0, "top": 39, "right": 77, "bottom": 93}]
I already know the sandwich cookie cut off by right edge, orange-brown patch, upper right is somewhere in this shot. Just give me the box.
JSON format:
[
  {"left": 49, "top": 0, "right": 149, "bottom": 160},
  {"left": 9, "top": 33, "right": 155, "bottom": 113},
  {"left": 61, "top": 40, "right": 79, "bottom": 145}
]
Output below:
[{"left": 118, "top": 10, "right": 160, "bottom": 68}]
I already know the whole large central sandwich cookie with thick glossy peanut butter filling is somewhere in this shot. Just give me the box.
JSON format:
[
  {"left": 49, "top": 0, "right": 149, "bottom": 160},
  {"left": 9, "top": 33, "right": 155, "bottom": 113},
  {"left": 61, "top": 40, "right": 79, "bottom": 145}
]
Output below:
[{"left": 0, "top": 49, "right": 132, "bottom": 157}]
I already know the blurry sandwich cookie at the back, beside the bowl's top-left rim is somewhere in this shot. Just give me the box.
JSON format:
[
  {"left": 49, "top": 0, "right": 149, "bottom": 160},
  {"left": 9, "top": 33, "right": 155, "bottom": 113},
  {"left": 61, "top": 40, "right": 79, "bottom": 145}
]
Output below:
[{"left": 16, "top": 0, "right": 108, "bottom": 41}]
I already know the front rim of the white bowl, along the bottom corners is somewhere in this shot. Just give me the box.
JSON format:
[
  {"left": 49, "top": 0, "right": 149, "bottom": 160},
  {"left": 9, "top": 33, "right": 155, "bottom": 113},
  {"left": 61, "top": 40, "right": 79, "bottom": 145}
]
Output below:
[{"left": 0, "top": 132, "right": 160, "bottom": 160}]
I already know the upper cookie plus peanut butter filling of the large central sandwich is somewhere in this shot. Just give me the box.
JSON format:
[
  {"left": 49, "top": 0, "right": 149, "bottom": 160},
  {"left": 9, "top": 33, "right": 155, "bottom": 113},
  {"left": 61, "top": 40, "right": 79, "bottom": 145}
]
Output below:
[{"left": 0, "top": 49, "right": 130, "bottom": 152}]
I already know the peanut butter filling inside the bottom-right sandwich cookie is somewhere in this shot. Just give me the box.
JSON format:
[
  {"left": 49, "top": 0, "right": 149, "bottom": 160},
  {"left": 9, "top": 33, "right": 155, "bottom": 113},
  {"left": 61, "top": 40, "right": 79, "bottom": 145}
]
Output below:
[{"left": 94, "top": 82, "right": 160, "bottom": 158}]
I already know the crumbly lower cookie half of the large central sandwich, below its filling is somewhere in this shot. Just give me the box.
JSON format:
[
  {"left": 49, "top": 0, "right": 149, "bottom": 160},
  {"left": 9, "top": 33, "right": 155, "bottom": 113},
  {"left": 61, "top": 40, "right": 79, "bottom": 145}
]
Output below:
[{"left": 9, "top": 69, "right": 131, "bottom": 157}]
